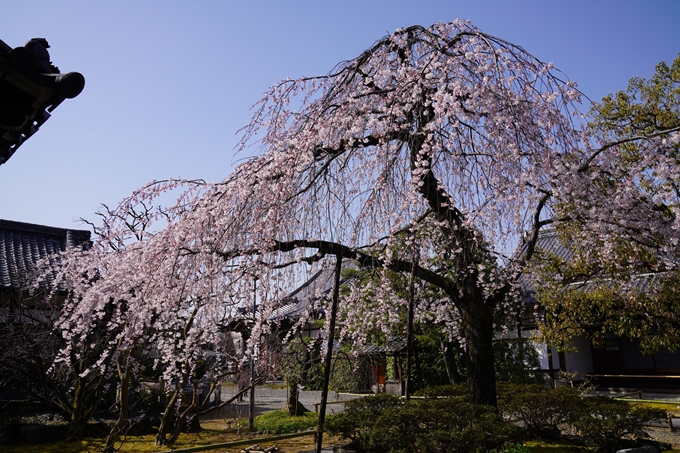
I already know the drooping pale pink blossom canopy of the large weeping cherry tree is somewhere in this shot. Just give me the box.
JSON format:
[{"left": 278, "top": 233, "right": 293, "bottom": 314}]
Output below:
[{"left": 30, "top": 21, "right": 678, "bottom": 394}]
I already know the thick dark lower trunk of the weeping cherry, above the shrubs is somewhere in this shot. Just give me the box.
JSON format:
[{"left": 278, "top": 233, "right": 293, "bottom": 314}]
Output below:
[{"left": 459, "top": 302, "right": 497, "bottom": 407}]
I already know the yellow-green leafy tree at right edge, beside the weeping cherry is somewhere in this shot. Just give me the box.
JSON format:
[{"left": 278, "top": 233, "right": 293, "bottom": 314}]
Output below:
[{"left": 534, "top": 55, "right": 680, "bottom": 352}]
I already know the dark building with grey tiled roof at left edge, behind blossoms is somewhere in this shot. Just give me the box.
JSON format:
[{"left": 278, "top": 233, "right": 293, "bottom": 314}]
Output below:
[{"left": 0, "top": 220, "right": 90, "bottom": 404}]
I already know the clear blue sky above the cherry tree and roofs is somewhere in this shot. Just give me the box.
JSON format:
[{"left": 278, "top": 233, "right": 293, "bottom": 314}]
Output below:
[{"left": 0, "top": 0, "right": 680, "bottom": 228}]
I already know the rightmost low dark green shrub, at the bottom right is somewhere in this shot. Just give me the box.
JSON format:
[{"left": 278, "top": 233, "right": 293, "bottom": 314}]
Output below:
[{"left": 573, "top": 397, "right": 666, "bottom": 452}]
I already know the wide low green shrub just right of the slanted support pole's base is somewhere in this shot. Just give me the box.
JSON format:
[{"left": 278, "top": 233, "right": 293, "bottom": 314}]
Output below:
[{"left": 326, "top": 395, "right": 520, "bottom": 453}]
